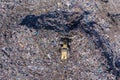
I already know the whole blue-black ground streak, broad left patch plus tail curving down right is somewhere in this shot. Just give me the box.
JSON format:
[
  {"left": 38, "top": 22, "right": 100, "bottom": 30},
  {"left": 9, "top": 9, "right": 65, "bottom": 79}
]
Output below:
[{"left": 20, "top": 10, "right": 120, "bottom": 76}]
